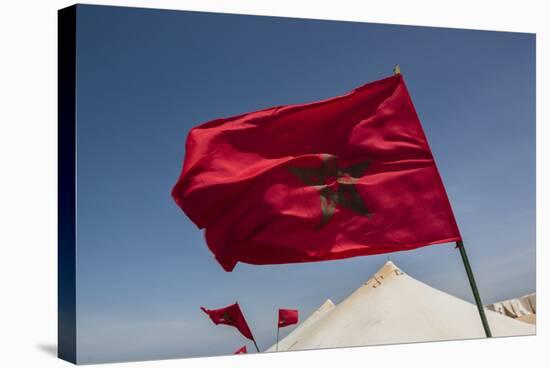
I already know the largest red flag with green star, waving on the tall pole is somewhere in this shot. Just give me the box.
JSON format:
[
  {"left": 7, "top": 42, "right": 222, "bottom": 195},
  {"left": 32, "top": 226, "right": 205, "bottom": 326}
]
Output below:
[{"left": 172, "top": 74, "right": 461, "bottom": 271}]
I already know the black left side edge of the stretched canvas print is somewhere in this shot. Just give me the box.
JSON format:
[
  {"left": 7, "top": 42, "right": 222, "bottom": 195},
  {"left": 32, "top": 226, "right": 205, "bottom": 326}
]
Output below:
[{"left": 57, "top": 5, "right": 77, "bottom": 364}]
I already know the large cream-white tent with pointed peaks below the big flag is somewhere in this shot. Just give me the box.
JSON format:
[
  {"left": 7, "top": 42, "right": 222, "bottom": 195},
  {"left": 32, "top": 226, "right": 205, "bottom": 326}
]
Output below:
[{"left": 267, "top": 261, "right": 535, "bottom": 351}]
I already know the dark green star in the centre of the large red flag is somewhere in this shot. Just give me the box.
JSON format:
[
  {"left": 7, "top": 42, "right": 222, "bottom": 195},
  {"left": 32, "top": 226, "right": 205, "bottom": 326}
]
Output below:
[{"left": 289, "top": 154, "right": 370, "bottom": 230}]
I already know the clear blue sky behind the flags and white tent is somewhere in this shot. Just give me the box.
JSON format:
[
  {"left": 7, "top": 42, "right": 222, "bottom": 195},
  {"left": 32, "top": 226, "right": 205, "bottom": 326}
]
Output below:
[{"left": 73, "top": 6, "right": 535, "bottom": 363}]
